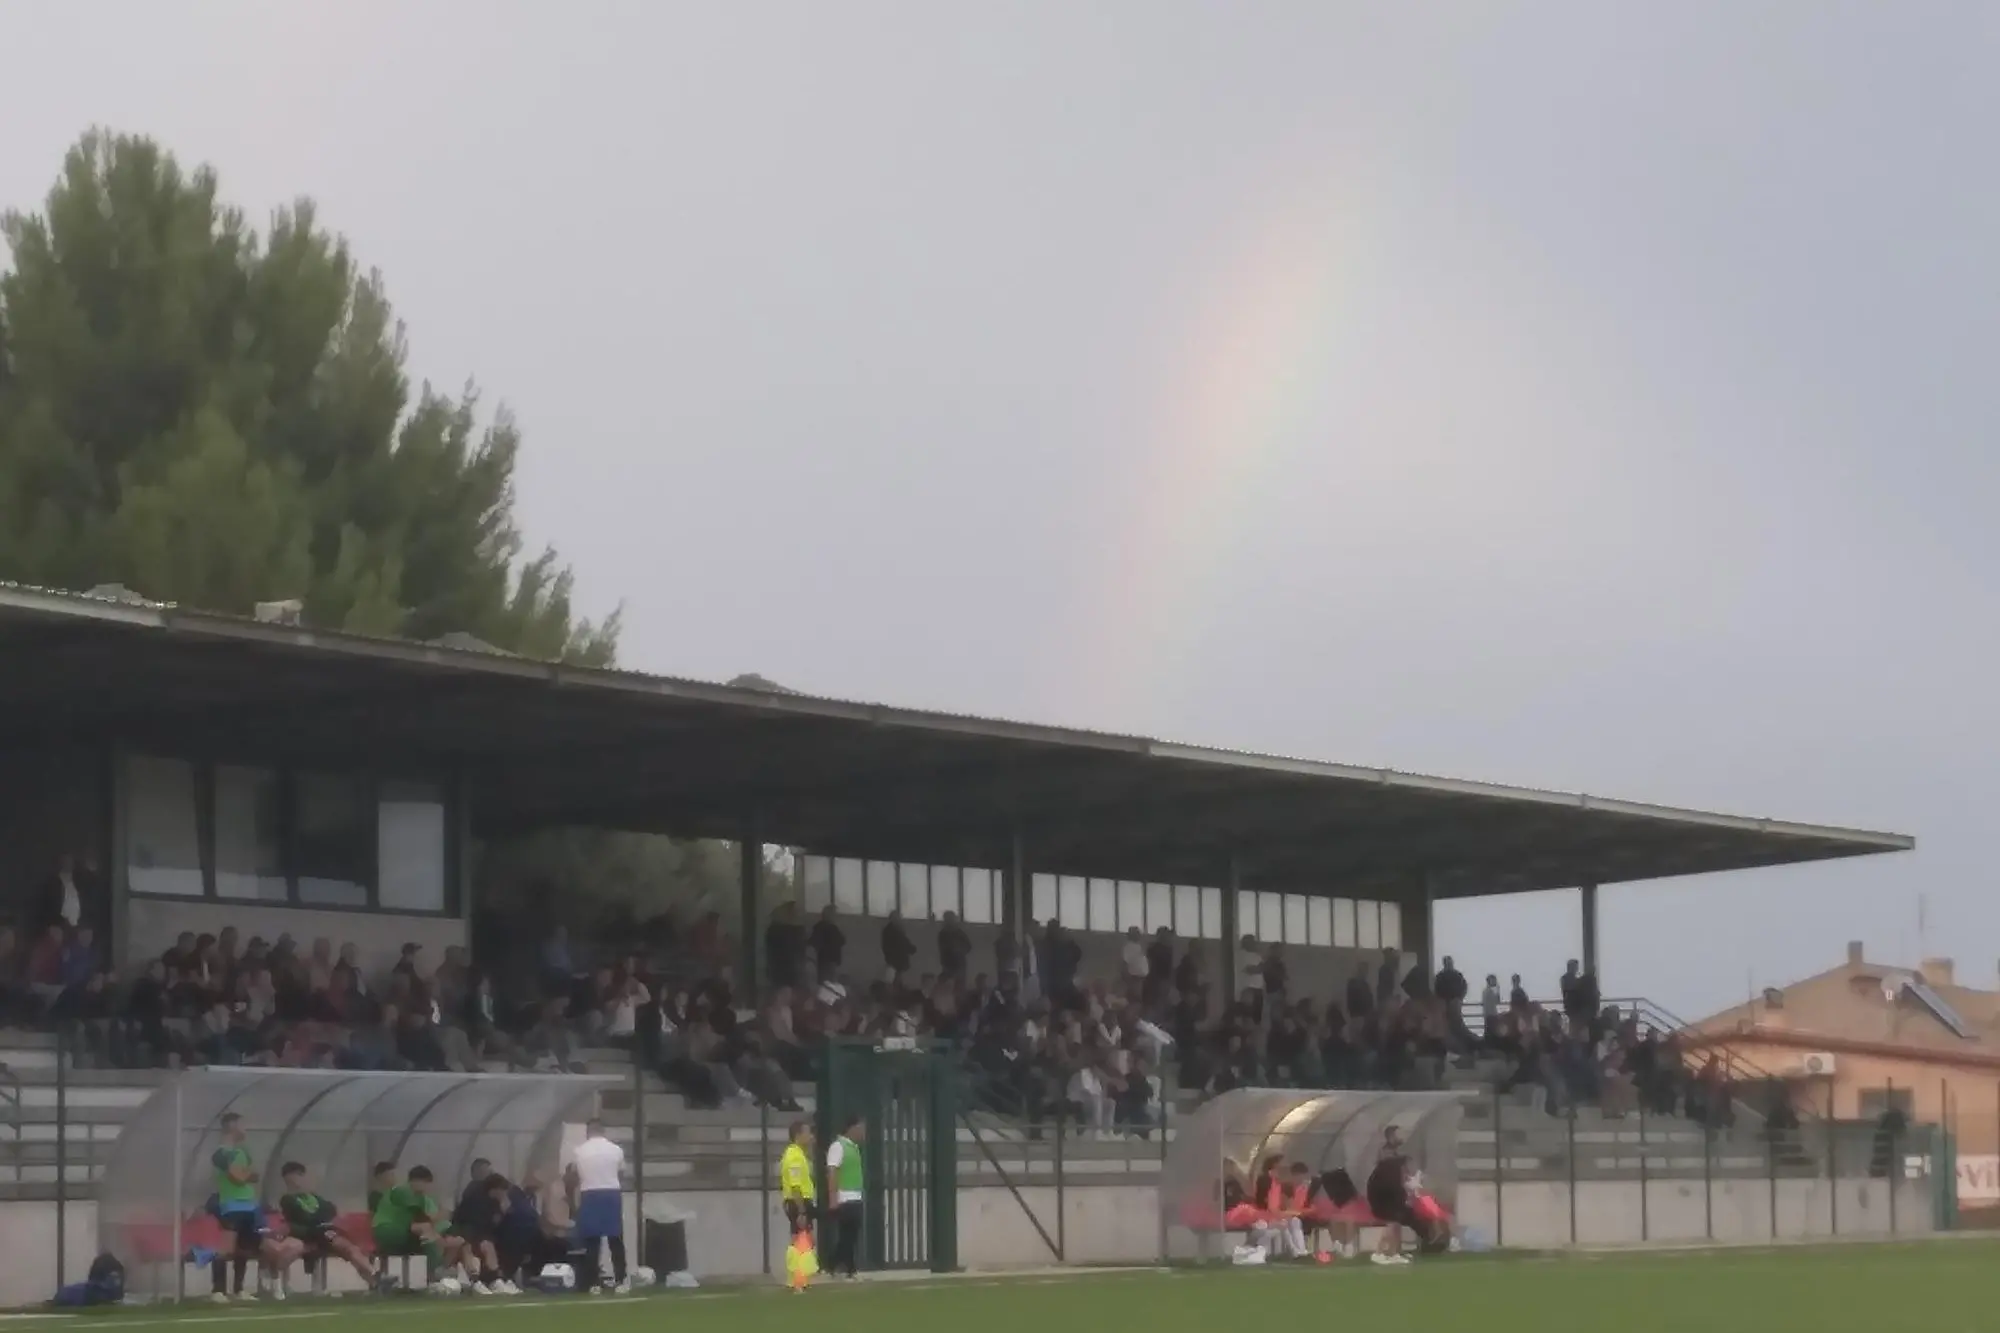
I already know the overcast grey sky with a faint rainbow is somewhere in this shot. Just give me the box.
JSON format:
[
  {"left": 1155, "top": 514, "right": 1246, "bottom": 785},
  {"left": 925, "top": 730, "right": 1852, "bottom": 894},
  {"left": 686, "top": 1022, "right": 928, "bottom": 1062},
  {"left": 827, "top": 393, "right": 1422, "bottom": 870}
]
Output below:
[{"left": 0, "top": 0, "right": 2000, "bottom": 1017}]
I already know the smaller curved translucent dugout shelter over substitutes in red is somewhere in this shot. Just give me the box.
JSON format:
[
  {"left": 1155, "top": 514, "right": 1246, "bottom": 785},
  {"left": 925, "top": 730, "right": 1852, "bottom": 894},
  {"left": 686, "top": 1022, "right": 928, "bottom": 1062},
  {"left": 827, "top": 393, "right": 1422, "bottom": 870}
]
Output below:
[{"left": 1160, "top": 1087, "right": 1464, "bottom": 1259}]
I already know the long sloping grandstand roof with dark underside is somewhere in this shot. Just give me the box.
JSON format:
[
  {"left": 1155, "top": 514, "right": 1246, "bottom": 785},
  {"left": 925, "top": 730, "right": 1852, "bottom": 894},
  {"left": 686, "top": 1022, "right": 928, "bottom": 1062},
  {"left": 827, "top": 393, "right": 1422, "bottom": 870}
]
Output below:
[{"left": 0, "top": 584, "right": 1914, "bottom": 899}]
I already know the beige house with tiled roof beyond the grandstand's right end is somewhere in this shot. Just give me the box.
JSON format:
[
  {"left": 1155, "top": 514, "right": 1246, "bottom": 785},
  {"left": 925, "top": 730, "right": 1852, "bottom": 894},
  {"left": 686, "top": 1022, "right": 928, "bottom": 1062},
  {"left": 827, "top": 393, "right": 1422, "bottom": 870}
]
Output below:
[{"left": 1692, "top": 943, "right": 2000, "bottom": 1209}]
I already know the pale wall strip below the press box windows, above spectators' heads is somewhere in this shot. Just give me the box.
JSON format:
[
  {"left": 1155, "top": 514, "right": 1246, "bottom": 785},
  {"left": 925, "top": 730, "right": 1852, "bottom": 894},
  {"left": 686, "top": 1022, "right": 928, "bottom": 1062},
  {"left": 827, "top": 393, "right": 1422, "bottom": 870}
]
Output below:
[{"left": 126, "top": 897, "right": 466, "bottom": 979}]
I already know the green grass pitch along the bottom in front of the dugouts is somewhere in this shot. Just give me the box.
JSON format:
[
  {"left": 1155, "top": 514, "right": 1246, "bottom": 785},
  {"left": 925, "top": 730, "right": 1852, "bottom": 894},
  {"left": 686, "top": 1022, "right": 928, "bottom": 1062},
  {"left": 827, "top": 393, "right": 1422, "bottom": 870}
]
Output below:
[{"left": 64, "top": 1239, "right": 2000, "bottom": 1333}]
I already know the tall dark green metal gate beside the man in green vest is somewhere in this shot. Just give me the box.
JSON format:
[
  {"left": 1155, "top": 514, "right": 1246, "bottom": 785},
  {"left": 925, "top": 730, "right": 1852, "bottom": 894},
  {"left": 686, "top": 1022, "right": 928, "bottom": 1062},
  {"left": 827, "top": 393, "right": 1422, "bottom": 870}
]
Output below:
[{"left": 818, "top": 1039, "right": 958, "bottom": 1273}]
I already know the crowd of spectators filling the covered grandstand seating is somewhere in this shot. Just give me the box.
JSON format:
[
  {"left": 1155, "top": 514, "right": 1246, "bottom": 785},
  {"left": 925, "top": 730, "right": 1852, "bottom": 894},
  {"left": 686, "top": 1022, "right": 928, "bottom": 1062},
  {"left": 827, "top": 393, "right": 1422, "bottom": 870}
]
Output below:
[{"left": 0, "top": 876, "right": 1732, "bottom": 1133}]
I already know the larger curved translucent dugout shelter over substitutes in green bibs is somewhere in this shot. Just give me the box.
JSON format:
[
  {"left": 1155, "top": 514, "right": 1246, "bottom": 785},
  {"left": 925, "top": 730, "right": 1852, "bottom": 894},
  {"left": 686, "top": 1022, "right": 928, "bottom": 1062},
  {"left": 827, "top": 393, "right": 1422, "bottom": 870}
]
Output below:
[{"left": 98, "top": 1069, "right": 618, "bottom": 1297}]
